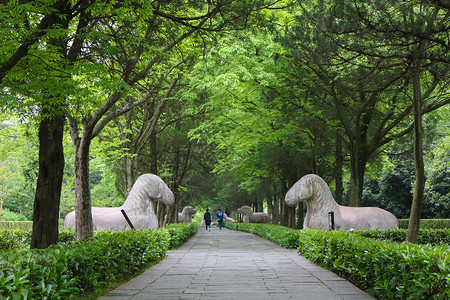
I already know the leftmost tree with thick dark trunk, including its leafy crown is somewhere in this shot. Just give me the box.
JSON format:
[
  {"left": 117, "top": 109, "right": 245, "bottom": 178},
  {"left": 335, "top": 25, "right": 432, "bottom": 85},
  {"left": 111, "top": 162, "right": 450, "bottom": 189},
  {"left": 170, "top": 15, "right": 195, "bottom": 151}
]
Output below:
[{"left": 0, "top": 0, "right": 91, "bottom": 248}]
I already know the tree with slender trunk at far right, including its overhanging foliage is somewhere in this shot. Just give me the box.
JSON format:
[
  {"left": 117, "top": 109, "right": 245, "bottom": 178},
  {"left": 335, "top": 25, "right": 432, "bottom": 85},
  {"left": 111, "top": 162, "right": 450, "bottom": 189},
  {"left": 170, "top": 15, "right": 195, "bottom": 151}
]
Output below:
[{"left": 299, "top": 0, "right": 450, "bottom": 242}]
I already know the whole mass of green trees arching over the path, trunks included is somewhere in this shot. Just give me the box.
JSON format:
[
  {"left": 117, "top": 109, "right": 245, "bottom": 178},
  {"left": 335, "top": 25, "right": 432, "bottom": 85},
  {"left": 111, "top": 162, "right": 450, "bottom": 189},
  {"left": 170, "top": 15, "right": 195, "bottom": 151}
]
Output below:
[{"left": 0, "top": 0, "right": 450, "bottom": 248}]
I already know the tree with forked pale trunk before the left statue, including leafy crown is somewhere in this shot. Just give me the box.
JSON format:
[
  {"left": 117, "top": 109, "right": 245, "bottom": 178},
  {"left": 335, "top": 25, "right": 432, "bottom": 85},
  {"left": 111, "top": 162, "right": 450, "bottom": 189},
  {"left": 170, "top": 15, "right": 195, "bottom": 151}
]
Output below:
[{"left": 69, "top": 0, "right": 276, "bottom": 239}]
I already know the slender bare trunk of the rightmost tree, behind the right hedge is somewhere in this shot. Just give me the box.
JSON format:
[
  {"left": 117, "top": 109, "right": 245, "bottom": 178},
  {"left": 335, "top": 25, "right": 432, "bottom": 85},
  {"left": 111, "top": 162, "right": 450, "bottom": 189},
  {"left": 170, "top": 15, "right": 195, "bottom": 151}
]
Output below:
[{"left": 406, "top": 62, "right": 425, "bottom": 243}]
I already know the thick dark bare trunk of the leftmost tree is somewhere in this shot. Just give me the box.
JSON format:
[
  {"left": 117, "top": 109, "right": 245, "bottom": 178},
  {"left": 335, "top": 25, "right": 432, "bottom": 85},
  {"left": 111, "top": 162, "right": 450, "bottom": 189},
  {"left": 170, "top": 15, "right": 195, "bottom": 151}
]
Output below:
[{"left": 30, "top": 109, "right": 65, "bottom": 249}]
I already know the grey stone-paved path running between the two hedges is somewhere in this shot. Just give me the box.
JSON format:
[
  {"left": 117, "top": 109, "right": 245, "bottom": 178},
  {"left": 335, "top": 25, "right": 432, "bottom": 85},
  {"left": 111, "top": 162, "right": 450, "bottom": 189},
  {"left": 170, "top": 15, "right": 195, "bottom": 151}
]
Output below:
[{"left": 99, "top": 227, "right": 374, "bottom": 300}]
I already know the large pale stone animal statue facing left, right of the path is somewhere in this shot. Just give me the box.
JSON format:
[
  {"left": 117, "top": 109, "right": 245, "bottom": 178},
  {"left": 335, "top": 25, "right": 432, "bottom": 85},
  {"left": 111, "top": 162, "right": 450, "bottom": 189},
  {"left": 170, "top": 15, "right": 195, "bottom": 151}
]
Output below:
[{"left": 284, "top": 174, "right": 398, "bottom": 230}]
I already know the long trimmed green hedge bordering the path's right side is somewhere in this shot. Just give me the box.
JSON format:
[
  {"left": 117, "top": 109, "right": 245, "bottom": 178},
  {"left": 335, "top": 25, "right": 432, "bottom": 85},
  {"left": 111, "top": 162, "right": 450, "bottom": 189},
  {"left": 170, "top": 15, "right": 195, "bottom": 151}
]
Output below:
[{"left": 226, "top": 223, "right": 450, "bottom": 299}]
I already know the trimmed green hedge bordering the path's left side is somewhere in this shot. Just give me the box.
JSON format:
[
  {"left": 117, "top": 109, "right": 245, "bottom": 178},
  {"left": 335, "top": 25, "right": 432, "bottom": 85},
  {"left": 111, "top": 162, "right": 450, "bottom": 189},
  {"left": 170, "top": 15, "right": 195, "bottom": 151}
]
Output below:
[{"left": 0, "top": 224, "right": 197, "bottom": 299}]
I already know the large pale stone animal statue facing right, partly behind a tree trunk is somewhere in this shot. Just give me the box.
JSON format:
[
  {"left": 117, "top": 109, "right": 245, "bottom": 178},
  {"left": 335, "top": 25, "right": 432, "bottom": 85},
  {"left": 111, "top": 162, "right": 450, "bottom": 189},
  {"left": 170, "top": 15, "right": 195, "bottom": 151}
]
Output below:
[{"left": 64, "top": 174, "right": 175, "bottom": 231}]
